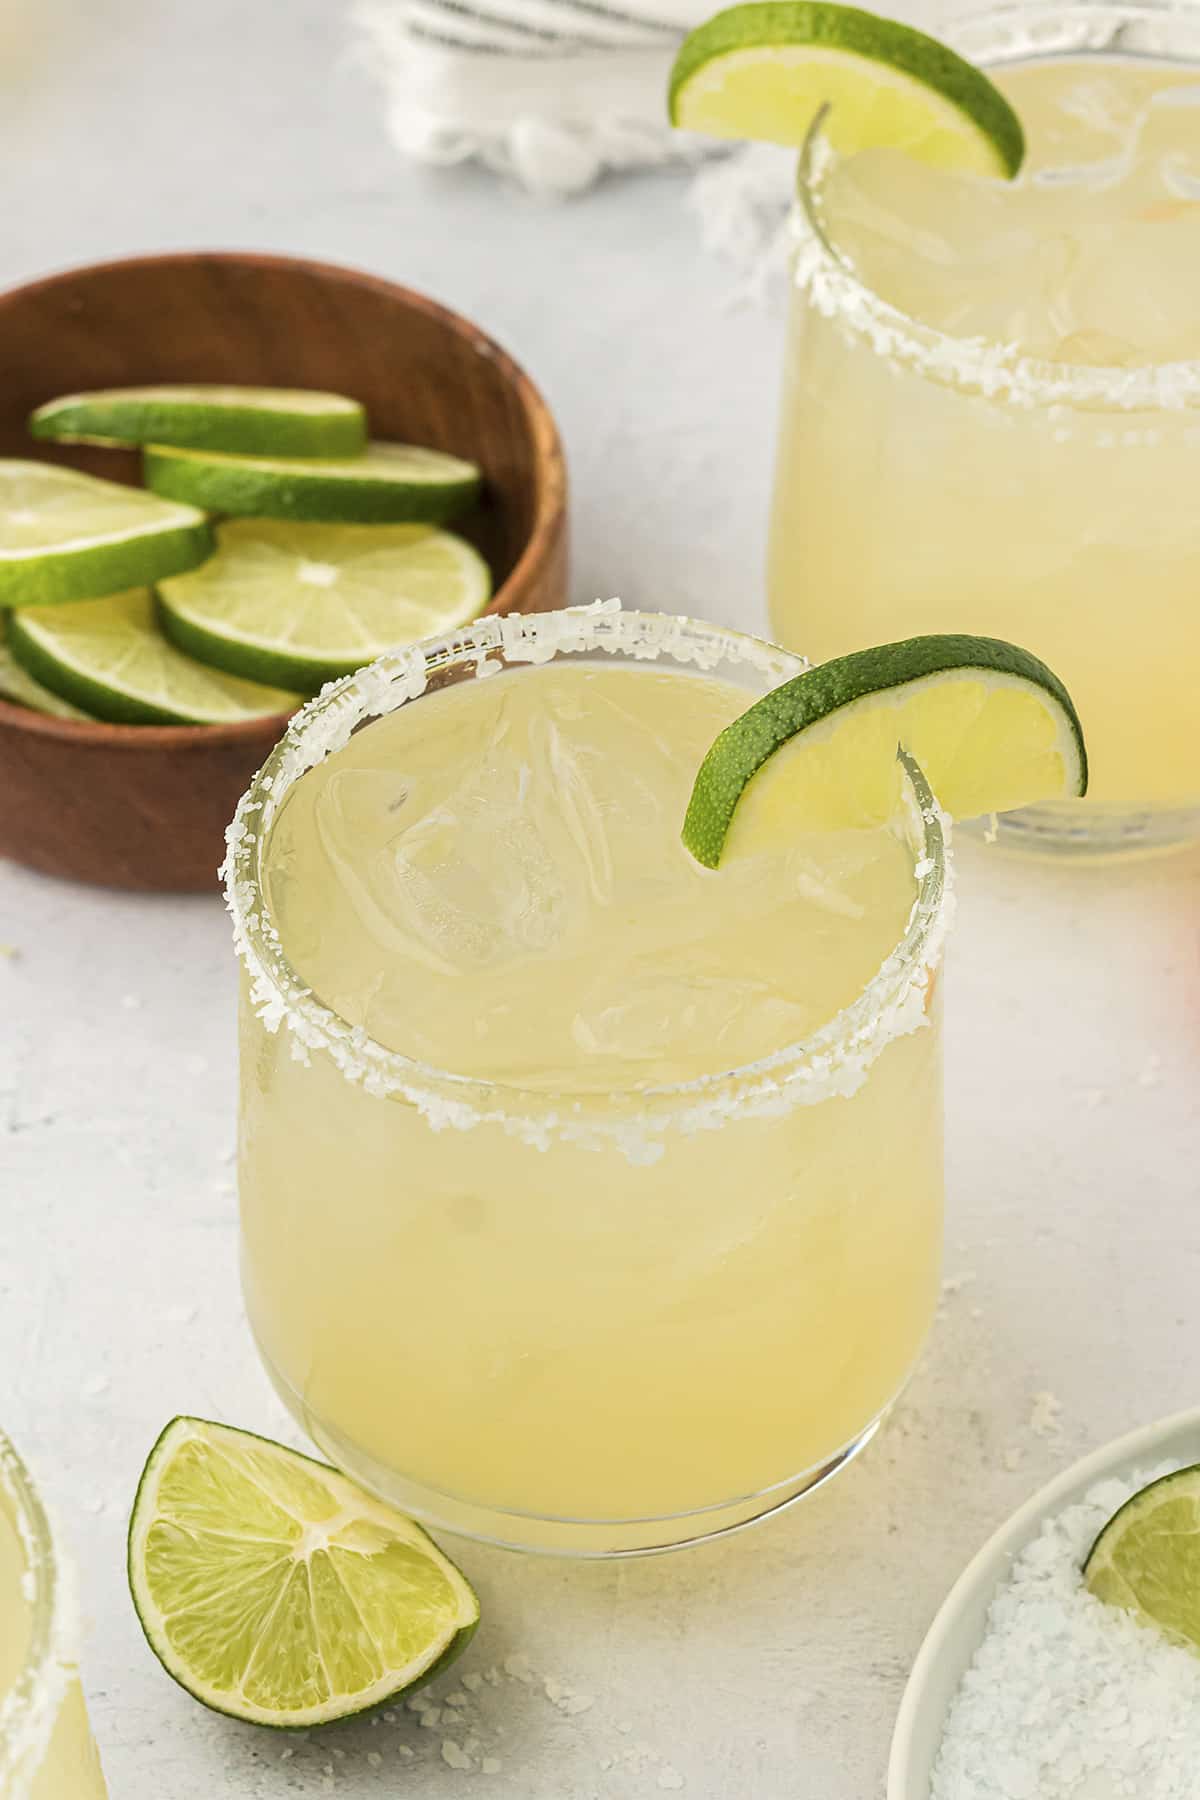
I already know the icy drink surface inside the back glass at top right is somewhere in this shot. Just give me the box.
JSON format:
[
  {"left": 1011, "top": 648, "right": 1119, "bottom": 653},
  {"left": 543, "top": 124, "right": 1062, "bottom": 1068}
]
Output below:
[{"left": 824, "top": 58, "right": 1200, "bottom": 367}]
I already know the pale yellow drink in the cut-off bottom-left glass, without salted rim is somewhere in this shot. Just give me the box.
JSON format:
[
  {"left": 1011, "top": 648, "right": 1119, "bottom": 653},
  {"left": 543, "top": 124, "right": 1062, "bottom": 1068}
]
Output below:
[{"left": 0, "top": 1476, "right": 106, "bottom": 1800}]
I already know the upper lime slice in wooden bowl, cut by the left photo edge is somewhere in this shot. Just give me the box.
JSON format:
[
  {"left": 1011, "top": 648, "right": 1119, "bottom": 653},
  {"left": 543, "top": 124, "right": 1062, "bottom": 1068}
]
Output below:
[{"left": 0, "top": 459, "right": 212, "bottom": 607}]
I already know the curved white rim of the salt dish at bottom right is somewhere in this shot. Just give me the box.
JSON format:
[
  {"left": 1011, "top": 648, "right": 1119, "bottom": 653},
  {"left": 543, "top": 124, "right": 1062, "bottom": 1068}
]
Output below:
[{"left": 885, "top": 1408, "right": 1200, "bottom": 1800}]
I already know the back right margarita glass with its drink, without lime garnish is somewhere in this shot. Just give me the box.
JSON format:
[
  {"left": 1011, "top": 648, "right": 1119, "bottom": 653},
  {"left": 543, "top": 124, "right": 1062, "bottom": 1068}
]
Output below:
[{"left": 768, "top": 4, "right": 1200, "bottom": 853}]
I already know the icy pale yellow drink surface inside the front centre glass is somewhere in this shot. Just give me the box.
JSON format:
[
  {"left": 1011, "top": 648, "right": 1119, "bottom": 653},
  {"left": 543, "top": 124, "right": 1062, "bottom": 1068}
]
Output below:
[{"left": 266, "top": 662, "right": 916, "bottom": 1093}]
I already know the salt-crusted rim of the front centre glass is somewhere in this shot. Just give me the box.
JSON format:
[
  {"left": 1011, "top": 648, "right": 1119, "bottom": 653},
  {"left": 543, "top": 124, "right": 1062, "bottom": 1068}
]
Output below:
[{"left": 221, "top": 599, "right": 952, "bottom": 1161}]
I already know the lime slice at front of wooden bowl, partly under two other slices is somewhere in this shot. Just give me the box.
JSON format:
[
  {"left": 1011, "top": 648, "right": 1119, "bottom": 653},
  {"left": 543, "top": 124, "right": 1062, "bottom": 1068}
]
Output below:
[{"left": 9, "top": 587, "right": 300, "bottom": 725}]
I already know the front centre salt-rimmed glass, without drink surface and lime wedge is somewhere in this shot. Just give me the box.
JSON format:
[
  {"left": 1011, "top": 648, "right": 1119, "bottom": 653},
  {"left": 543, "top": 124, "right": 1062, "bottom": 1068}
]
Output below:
[{"left": 227, "top": 607, "right": 948, "bottom": 1555}]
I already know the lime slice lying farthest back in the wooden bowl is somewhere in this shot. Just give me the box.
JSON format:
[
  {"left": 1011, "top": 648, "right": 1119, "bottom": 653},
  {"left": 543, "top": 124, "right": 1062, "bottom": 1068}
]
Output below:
[{"left": 29, "top": 385, "right": 367, "bottom": 455}]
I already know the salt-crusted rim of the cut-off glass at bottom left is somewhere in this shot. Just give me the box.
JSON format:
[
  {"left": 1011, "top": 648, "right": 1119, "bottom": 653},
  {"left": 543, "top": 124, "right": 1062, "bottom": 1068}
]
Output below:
[{"left": 0, "top": 1431, "right": 79, "bottom": 1800}]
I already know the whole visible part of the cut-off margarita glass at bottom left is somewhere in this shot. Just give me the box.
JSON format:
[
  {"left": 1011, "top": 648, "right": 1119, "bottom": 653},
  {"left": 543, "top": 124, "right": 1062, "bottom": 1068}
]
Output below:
[{"left": 0, "top": 1433, "right": 106, "bottom": 1800}]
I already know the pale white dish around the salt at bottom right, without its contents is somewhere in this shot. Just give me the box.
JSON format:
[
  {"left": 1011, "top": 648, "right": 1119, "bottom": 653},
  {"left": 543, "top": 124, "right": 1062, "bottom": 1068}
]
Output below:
[{"left": 887, "top": 1411, "right": 1200, "bottom": 1800}]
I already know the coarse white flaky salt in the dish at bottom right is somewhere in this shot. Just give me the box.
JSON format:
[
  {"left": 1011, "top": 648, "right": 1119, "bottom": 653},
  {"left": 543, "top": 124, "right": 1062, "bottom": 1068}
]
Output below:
[{"left": 930, "top": 1469, "right": 1200, "bottom": 1800}]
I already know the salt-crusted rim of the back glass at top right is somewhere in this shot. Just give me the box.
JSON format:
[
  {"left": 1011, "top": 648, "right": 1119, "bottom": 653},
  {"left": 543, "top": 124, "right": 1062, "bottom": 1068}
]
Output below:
[{"left": 792, "top": 0, "right": 1200, "bottom": 412}]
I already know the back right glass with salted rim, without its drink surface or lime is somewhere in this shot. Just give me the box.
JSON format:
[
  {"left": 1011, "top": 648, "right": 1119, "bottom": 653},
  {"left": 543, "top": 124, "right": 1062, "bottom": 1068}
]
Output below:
[{"left": 770, "top": 0, "right": 1200, "bottom": 855}]
